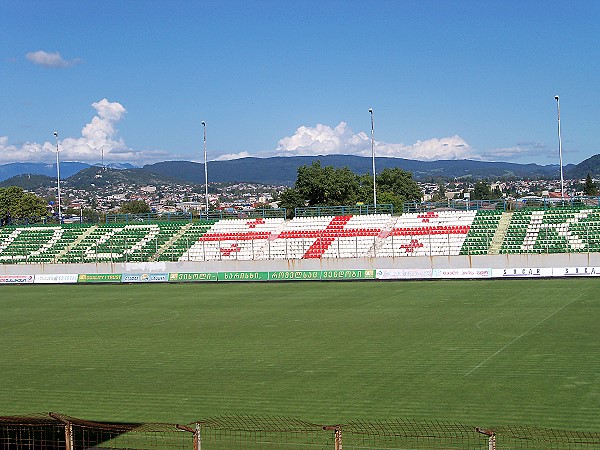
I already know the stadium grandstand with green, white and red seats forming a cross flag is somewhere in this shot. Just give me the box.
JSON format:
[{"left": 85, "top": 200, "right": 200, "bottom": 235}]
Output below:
[{"left": 0, "top": 204, "right": 600, "bottom": 264}]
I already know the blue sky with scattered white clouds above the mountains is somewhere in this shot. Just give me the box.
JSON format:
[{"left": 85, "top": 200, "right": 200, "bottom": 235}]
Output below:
[{"left": 0, "top": 0, "right": 600, "bottom": 165}]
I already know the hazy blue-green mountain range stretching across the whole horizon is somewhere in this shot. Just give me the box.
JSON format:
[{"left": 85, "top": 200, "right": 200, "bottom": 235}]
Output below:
[{"left": 0, "top": 155, "right": 600, "bottom": 188}]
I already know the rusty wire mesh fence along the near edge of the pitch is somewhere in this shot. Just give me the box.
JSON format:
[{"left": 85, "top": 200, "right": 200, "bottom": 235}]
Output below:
[{"left": 0, "top": 413, "right": 600, "bottom": 450}]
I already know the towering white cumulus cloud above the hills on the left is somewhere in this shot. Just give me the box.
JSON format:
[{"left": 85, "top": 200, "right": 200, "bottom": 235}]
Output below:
[{"left": 0, "top": 99, "right": 168, "bottom": 164}]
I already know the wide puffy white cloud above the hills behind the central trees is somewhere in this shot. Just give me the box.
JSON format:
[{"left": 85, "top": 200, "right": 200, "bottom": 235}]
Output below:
[{"left": 275, "top": 122, "right": 478, "bottom": 161}]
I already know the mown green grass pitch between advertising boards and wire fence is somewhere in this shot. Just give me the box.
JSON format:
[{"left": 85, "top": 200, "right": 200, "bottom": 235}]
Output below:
[{"left": 0, "top": 278, "right": 600, "bottom": 431}]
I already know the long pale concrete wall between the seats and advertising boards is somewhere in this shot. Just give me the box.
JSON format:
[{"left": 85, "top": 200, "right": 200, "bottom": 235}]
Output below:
[{"left": 0, "top": 253, "right": 600, "bottom": 275}]
